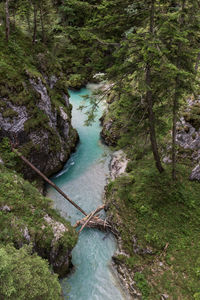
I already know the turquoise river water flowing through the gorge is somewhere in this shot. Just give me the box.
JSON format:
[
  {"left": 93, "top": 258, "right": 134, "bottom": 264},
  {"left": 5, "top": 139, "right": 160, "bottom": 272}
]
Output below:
[{"left": 48, "top": 88, "right": 127, "bottom": 300}]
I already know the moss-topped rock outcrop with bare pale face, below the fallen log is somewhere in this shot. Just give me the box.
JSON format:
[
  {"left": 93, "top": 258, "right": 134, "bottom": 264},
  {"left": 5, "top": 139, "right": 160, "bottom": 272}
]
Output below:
[{"left": 0, "top": 167, "right": 78, "bottom": 277}]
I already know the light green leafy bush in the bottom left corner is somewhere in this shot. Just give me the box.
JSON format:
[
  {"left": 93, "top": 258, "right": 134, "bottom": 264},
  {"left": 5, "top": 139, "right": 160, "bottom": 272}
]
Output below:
[{"left": 0, "top": 245, "right": 62, "bottom": 300}]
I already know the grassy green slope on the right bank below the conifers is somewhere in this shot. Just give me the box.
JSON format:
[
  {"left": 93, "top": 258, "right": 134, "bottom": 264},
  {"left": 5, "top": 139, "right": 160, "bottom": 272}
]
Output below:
[{"left": 106, "top": 155, "right": 200, "bottom": 300}]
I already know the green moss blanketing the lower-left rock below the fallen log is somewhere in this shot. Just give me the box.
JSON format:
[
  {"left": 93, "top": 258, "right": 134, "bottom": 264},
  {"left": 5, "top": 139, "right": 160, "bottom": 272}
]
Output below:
[{"left": 0, "top": 165, "right": 77, "bottom": 274}]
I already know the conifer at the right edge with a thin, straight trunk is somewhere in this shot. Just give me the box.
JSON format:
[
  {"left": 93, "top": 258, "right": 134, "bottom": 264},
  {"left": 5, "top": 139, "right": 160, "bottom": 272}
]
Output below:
[{"left": 159, "top": 0, "right": 199, "bottom": 180}]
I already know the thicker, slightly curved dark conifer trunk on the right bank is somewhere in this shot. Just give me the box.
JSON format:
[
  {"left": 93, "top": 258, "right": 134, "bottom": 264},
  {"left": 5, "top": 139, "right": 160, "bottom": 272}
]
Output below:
[{"left": 145, "top": 0, "right": 164, "bottom": 173}]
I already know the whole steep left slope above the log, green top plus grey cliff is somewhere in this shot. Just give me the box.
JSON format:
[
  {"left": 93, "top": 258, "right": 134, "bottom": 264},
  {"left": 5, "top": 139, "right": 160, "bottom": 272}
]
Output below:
[{"left": 0, "top": 23, "right": 78, "bottom": 179}]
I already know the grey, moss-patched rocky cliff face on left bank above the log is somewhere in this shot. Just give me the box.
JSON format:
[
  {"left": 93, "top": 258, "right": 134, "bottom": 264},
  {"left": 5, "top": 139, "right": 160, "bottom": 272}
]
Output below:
[{"left": 0, "top": 71, "right": 78, "bottom": 179}]
